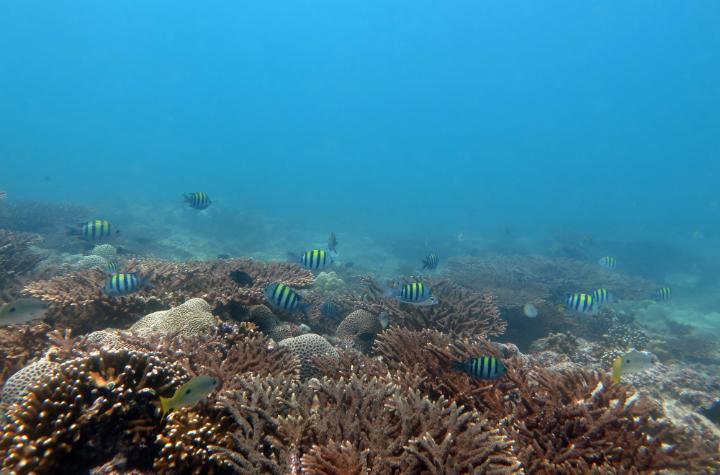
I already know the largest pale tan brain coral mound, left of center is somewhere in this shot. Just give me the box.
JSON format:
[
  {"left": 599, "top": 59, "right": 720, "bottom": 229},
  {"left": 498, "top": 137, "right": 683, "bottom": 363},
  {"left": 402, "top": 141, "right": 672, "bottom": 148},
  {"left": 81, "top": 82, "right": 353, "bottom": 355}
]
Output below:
[{"left": 130, "top": 298, "right": 218, "bottom": 335}]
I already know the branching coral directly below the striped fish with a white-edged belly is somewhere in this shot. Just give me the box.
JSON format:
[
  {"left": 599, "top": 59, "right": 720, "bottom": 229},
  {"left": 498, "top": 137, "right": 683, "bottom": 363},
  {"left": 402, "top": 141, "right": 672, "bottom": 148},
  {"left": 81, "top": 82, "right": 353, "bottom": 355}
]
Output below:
[{"left": 354, "top": 278, "right": 507, "bottom": 337}]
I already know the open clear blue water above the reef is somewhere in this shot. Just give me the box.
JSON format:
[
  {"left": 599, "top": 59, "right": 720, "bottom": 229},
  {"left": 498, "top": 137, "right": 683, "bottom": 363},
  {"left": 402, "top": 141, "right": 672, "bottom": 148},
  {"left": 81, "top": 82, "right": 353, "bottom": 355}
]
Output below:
[{"left": 0, "top": 0, "right": 720, "bottom": 266}]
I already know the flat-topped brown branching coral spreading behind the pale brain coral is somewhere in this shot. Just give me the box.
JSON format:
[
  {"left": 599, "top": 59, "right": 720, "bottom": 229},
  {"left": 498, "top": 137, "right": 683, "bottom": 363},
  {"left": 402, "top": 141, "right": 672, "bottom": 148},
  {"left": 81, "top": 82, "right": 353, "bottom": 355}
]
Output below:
[{"left": 24, "top": 259, "right": 313, "bottom": 333}]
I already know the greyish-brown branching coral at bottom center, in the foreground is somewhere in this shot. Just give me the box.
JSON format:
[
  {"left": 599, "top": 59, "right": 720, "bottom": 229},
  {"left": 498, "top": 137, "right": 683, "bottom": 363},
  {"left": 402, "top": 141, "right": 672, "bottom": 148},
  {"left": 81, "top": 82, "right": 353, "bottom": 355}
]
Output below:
[{"left": 195, "top": 376, "right": 519, "bottom": 474}]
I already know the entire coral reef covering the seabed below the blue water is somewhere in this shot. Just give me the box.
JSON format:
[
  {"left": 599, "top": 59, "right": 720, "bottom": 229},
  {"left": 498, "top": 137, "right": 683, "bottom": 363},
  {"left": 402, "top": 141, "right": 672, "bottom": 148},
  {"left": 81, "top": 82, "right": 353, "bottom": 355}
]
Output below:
[{"left": 0, "top": 218, "right": 720, "bottom": 475}]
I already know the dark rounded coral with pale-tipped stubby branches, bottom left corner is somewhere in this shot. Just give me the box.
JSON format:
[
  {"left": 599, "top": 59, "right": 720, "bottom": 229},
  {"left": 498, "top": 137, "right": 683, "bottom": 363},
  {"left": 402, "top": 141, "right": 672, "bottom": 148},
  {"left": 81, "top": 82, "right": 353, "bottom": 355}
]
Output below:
[{"left": 0, "top": 350, "right": 188, "bottom": 474}]
